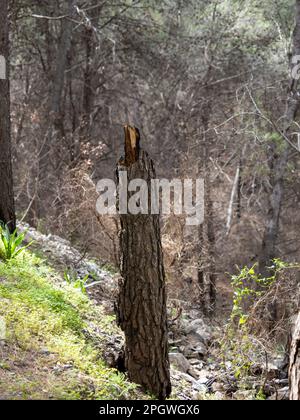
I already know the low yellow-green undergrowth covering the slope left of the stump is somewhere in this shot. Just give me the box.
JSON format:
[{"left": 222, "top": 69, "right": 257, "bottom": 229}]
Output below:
[{"left": 0, "top": 251, "right": 140, "bottom": 399}]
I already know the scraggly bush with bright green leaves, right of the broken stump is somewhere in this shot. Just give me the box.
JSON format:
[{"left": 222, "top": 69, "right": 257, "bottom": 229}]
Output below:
[{"left": 221, "top": 259, "right": 299, "bottom": 398}]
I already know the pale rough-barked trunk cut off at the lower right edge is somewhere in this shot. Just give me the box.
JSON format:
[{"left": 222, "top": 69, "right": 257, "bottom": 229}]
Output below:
[{"left": 289, "top": 313, "right": 300, "bottom": 401}]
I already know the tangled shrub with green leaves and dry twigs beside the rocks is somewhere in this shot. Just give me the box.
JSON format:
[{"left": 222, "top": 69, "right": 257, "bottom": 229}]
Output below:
[{"left": 221, "top": 259, "right": 299, "bottom": 392}]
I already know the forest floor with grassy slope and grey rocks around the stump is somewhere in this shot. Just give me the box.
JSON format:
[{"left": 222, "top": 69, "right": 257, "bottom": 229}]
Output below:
[{"left": 0, "top": 226, "right": 287, "bottom": 400}]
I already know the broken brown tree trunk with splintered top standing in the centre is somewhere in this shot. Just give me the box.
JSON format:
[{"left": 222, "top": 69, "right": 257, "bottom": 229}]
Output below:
[{"left": 117, "top": 126, "right": 171, "bottom": 399}]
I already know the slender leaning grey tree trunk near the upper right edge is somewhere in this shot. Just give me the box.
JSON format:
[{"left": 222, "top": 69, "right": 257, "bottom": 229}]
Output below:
[{"left": 259, "top": 0, "right": 300, "bottom": 276}]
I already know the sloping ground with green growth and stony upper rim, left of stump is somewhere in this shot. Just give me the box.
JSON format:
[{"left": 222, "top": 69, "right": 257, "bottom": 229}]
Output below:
[{"left": 0, "top": 227, "right": 195, "bottom": 400}]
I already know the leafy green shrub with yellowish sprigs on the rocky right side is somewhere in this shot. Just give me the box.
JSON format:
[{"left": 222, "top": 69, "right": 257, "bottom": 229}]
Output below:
[{"left": 221, "top": 259, "right": 295, "bottom": 386}]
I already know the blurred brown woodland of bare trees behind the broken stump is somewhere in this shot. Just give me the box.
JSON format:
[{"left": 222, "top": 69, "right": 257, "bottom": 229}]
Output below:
[{"left": 11, "top": 0, "right": 300, "bottom": 311}]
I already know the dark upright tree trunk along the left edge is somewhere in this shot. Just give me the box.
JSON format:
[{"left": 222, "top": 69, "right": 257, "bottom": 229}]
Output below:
[{"left": 0, "top": 0, "right": 16, "bottom": 230}]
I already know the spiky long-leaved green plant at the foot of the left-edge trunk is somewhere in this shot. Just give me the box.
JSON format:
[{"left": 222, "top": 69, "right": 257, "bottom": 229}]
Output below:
[{"left": 0, "top": 224, "right": 33, "bottom": 261}]
